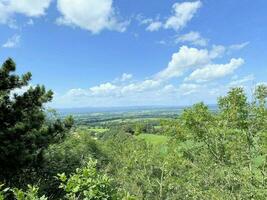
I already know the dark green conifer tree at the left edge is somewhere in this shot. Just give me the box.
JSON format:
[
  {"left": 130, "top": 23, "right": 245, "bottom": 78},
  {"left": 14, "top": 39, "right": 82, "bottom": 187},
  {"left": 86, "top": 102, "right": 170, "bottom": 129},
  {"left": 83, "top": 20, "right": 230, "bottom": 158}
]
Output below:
[{"left": 0, "top": 59, "right": 73, "bottom": 184}]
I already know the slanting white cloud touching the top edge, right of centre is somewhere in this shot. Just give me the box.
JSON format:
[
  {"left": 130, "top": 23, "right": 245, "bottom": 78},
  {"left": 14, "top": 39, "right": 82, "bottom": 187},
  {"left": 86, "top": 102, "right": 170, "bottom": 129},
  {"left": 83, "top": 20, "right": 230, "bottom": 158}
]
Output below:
[{"left": 164, "top": 1, "right": 202, "bottom": 31}]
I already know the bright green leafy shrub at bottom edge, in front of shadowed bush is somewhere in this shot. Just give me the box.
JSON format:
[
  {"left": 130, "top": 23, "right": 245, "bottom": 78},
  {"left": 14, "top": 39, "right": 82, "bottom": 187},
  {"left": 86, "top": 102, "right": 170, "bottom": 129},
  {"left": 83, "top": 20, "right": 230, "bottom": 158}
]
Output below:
[{"left": 58, "top": 160, "right": 116, "bottom": 200}]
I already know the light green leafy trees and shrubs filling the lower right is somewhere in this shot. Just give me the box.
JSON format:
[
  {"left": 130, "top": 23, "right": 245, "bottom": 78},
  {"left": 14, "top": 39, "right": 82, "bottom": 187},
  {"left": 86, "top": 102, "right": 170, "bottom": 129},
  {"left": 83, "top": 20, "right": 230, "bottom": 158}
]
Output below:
[{"left": 101, "top": 88, "right": 267, "bottom": 199}]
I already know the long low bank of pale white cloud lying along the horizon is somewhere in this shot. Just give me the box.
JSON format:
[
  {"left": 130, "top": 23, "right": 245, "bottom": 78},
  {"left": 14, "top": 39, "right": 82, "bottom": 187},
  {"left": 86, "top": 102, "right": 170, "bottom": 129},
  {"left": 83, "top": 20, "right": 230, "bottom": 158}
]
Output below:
[{"left": 54, "top": 79, "right": 211, "bottom": 107}]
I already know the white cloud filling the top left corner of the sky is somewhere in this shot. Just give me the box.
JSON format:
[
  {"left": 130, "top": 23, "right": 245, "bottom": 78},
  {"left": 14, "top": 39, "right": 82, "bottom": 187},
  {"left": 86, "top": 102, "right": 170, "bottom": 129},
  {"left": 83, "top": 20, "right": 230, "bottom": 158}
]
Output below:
[{"left": 0, "top": 0, "right": 52, "bottom": 27}]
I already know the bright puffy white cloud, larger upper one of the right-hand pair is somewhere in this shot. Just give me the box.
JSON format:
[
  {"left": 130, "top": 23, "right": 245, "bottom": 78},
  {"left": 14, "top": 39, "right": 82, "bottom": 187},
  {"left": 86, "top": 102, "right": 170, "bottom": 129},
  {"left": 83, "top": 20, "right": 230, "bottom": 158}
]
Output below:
[{"left": 156, "top": 46, "right": 211, "bottom": 79}]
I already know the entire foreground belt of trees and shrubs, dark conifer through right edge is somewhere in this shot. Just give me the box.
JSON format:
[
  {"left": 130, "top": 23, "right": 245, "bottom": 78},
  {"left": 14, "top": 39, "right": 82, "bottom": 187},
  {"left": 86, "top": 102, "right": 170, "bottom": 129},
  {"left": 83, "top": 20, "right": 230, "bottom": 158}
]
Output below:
[{"left": 0, "top": 59, "right": 267, "bottom": 200}]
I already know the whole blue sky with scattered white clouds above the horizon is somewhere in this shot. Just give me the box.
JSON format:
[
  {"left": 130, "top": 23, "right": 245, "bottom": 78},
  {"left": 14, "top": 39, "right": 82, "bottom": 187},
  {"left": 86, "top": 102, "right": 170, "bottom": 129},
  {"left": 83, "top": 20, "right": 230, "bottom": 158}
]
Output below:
[{"left": 0, "top": 0, "right": 267, "bottom": 108}]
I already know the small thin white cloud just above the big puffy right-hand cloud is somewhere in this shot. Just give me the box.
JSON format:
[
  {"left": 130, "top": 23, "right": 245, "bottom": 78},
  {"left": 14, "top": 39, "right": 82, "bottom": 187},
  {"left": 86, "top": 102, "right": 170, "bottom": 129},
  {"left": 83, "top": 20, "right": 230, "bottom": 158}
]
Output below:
[{"left": 176, "top": 31, "right": 208, "bottom": 46}]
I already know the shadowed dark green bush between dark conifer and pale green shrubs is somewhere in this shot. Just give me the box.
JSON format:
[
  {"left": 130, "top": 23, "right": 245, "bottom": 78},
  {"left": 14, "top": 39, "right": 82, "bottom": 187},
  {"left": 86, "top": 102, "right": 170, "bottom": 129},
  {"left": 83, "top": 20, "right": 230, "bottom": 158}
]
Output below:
[{"left": 39, "top": 129, "right": 107, "bottom": 199}]
